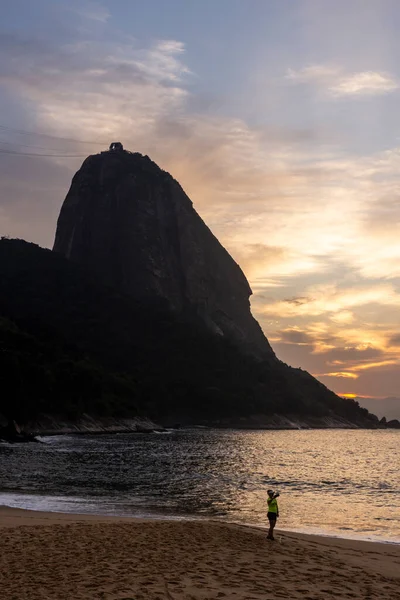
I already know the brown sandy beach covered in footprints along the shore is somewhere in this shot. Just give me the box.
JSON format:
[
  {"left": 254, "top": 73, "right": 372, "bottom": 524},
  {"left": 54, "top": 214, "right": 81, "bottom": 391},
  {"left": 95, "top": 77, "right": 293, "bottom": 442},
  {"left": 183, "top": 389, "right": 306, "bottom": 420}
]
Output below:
[{"left": 0, "top": 508, "right": 400, "bottom": 600}]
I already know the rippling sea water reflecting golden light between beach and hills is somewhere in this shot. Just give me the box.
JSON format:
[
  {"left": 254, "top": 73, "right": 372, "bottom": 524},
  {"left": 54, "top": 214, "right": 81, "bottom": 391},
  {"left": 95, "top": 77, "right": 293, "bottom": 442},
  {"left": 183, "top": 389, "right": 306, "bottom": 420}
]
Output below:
[{"left": 0, "top": 429, "right": 400, "bottom": 542}]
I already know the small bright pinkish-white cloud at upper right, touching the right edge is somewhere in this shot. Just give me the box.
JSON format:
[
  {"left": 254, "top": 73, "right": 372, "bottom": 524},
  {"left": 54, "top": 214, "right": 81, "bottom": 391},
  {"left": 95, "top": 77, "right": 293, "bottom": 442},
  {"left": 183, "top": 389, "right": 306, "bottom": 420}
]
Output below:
[{"left": 286, "top": 65, "right": 400, "bottom": 98}]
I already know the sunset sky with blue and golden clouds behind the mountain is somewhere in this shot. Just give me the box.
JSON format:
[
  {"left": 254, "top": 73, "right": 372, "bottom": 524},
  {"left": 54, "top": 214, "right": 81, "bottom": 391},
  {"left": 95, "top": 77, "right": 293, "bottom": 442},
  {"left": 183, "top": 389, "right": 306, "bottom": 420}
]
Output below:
[{"left": 0, "top": 0, "right": 400, "bottom": 415}]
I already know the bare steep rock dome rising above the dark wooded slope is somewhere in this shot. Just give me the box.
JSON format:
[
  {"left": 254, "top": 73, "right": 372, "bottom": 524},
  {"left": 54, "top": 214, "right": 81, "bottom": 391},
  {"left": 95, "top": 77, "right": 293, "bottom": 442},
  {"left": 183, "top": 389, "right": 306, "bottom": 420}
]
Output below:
[{"left": 54, "top": 150, "right": 275, "bottom": 359}]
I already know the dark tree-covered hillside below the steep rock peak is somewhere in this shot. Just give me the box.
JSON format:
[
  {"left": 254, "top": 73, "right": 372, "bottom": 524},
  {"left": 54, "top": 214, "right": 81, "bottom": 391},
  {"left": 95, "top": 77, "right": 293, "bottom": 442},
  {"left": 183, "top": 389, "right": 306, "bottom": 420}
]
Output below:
[{"left": 0, "top": 239, "right": 374, "bottom": 422}]
